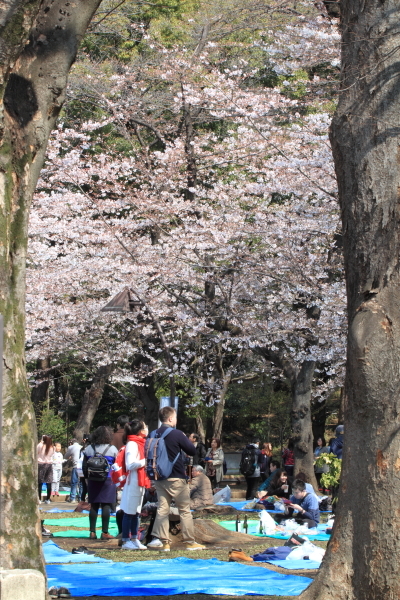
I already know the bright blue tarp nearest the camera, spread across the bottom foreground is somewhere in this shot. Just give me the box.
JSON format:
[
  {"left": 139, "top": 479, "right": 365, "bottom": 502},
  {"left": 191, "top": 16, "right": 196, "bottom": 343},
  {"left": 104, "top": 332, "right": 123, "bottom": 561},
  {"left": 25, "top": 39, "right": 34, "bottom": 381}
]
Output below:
[{"left": 46, "top": 557, "right": 312, "bottom": 597}]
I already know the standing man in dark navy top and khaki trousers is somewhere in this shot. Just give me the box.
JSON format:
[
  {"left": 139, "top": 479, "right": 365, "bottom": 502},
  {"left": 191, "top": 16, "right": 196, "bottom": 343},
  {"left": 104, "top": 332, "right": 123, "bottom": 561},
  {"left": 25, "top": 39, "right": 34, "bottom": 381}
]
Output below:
[{"left": 147, "top": 406, "right": 205, "bottom": 552}]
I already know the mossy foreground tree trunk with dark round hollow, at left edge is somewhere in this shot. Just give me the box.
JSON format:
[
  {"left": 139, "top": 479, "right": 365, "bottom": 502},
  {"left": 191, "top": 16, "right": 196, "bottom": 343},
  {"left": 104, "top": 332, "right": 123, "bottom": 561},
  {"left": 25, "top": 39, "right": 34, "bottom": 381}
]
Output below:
[{"left": 0, "top": 0, "right": 100, "bottom": 571}]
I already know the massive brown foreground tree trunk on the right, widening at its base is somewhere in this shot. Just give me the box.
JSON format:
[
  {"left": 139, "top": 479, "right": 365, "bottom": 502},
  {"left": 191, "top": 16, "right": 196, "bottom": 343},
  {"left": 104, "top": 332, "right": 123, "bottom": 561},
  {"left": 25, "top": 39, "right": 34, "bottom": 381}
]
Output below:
[{"left": 302, "top": 0, "right": 400, "bottom": 600}]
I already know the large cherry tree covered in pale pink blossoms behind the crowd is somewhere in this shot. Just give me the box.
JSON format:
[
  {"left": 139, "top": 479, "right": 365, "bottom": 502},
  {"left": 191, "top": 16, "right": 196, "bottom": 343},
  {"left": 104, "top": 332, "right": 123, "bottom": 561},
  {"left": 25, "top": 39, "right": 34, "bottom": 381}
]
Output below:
[{"left": 28, "top": 12, "right": 345, "bottom": 482}]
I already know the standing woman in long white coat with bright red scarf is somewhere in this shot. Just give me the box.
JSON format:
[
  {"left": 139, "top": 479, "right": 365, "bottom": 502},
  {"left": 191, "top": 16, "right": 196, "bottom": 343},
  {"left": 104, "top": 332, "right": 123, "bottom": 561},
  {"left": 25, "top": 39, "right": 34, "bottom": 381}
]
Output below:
[{"left": 121, "top": 419, "right": 150, "bottom": 550}]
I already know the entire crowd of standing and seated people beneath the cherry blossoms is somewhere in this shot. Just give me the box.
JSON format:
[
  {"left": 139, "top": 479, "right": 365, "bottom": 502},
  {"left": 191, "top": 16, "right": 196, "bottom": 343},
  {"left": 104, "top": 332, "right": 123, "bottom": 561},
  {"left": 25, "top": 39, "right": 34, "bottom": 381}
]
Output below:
[{"left": 37, "top": 418, "right": 344, "bottom": 552}]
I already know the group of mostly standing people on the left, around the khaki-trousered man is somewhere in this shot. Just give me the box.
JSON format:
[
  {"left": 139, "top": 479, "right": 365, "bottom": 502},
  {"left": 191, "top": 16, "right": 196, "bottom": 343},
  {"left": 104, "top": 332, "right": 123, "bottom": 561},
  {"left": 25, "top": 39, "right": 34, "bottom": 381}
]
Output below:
[{"left": 37, "top": 407, "right": 230, "bottom": 551}]
